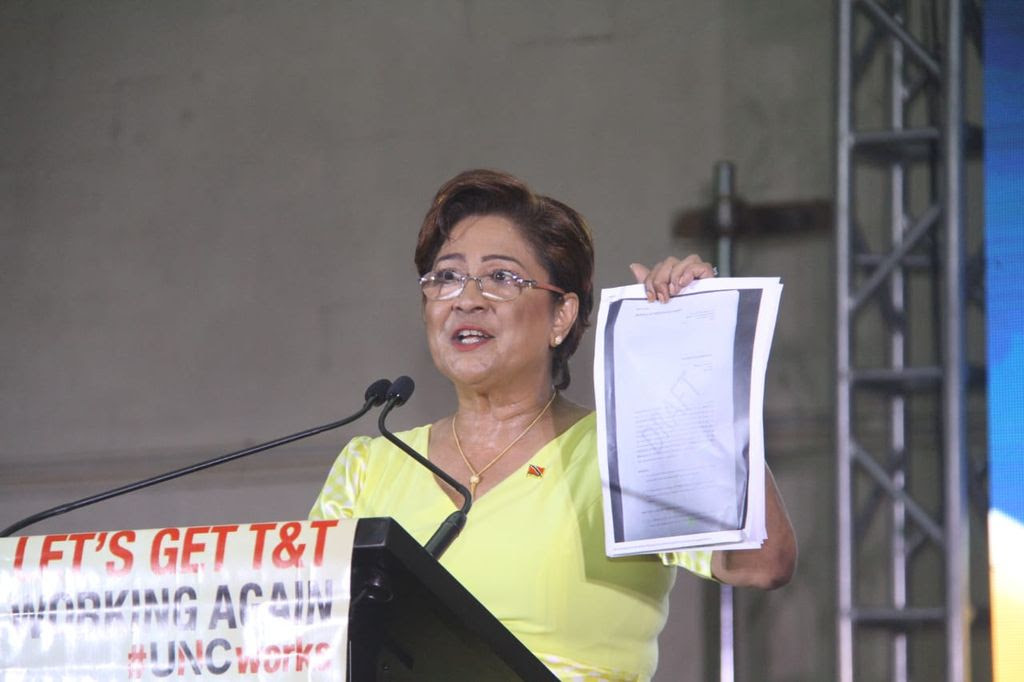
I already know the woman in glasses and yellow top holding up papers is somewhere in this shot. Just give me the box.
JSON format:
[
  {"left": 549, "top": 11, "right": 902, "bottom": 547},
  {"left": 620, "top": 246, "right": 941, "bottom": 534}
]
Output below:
[{"left": 311, "top": 170, "right": 796, "bottom": 680}]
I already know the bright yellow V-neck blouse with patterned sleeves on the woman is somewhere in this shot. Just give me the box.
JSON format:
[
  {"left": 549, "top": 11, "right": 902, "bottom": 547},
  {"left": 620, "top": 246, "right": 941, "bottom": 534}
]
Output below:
[{"left": 310, "top": 413, "right": 711, "bottom": 681}]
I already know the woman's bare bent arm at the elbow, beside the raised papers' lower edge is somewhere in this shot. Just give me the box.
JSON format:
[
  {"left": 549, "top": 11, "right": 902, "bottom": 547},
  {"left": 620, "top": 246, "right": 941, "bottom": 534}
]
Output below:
[{"left": 711, "top": 464, "right": 797, "bottom": 590}]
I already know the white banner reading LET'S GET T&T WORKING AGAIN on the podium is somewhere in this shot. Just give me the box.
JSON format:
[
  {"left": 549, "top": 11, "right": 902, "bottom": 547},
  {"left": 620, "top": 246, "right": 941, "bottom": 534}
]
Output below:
[{"left": 0, "top": 520, "right": 355, "bottom": 682}]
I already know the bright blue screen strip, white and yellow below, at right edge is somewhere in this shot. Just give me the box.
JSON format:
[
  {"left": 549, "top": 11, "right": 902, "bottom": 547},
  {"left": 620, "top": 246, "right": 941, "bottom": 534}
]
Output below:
[{"left": 985, "top": 0, "right": 1024, "bottom": 682}]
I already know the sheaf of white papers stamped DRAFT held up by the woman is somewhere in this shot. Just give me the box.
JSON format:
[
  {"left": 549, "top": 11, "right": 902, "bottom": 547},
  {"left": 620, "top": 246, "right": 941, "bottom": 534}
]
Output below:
[{"left": 594, "top": 278, "right": 782, "bottom": 556}]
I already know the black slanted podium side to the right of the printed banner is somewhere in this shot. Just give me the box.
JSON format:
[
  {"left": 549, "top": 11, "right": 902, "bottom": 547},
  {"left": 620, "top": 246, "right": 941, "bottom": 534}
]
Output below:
[{"left": 348, "top": 518, "right": 555, "bottom": 682}]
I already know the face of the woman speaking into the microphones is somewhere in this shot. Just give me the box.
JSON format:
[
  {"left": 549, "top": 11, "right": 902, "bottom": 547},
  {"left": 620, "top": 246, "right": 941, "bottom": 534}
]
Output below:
[{"left": 423, "top": 215, "right": 578, "bottom": 390}]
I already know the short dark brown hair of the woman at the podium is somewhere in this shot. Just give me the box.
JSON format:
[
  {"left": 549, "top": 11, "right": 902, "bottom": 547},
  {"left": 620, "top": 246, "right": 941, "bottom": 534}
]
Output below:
[{"left": 416, "top": 169, "right": 594, "bottom": 389}]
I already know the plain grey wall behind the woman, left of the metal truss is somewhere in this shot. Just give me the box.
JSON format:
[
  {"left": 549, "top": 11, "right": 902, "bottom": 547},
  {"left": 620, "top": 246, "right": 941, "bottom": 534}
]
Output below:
[{"left": 0, "top": 0, "right": 835, "bottom": 680}]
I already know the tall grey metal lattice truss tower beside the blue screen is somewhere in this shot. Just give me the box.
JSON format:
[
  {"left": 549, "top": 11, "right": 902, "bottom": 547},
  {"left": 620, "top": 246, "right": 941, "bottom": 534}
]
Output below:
[{"left": 836, "top": 0, "right": 981, "bottom": 682}]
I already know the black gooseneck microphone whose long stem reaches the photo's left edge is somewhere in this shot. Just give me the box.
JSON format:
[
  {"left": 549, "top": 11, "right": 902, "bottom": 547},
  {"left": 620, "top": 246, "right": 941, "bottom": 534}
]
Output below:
[{"left": 0, "top": 377, "right": 393, "bottom": 538}]
